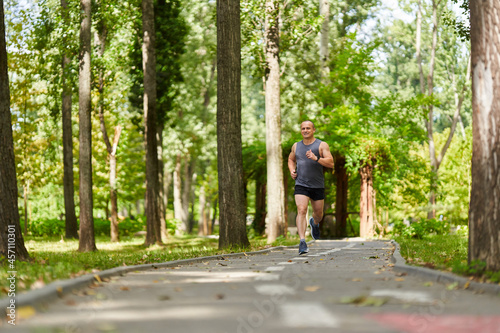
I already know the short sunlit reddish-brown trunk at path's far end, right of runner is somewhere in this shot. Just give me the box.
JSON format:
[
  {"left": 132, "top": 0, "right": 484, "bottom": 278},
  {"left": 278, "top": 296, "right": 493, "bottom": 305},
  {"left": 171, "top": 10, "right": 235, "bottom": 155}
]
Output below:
[{"left": 359, "top": 165, "right": 374, "bottom": 238}]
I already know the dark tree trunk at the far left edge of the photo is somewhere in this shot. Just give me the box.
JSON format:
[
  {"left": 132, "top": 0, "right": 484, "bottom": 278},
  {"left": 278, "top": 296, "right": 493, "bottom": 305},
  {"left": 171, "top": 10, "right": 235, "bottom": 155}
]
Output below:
[{"left": 0, "top": 1, "right": 29, "bottom": 260}]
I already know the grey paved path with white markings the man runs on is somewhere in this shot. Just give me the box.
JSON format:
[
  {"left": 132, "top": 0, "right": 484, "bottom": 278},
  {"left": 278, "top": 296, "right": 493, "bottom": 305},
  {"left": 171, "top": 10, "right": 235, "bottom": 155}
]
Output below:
[{"left": 0, "top": 240, "right": 500, "bottom": 333}]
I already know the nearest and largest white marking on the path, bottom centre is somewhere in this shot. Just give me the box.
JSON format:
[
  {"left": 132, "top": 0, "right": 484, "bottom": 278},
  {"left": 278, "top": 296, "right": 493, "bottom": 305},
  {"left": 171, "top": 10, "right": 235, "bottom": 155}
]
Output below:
[{"left": 280, "top": 303, "right": 340, "bottom": 327}]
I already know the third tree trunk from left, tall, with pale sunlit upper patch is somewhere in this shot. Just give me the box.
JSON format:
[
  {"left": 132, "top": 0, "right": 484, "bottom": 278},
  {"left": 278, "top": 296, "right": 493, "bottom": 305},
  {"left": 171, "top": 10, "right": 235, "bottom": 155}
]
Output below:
[{"left": 78, "top": 0, "right": 97, "bottom": 252}]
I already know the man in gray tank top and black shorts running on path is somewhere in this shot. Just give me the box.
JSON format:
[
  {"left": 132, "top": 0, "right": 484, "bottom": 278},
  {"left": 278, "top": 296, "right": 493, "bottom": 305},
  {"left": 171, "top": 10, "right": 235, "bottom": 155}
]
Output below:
[{"left": 288, "top": 120, "right": 333, "bottom": 254}]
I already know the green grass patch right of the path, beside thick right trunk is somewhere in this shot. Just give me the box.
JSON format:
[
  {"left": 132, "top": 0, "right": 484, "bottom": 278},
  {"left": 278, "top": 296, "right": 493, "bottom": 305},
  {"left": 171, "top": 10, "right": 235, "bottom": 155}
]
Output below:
[{"left": 395, "top": 235, "right": 500, "bottom": 283}]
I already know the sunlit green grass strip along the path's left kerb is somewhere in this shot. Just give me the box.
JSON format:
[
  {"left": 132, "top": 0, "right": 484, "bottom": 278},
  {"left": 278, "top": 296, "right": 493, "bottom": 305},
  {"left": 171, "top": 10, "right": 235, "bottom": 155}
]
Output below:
[{"left": 0, "top": 232, "right": 298, "bottom": 297}]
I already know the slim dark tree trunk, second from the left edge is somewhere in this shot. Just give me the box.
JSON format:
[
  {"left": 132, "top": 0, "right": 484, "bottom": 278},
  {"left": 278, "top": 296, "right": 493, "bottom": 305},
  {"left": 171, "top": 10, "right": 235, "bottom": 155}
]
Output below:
[{"left": 61, "top": 0, "right": 78, "bottom": 239}]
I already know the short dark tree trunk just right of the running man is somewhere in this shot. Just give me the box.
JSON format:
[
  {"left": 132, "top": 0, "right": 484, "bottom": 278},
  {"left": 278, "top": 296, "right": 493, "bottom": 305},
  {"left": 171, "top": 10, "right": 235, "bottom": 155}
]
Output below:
[{"left": 334, "top": 155, "right": 348, "bottom": 237}]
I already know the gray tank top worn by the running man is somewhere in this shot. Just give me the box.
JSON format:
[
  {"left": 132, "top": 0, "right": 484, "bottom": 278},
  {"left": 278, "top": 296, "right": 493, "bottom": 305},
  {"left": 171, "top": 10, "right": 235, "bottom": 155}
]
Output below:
[{"left": 295, "top": 139, "right": 325, "bottom": 188}]
